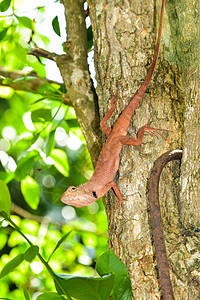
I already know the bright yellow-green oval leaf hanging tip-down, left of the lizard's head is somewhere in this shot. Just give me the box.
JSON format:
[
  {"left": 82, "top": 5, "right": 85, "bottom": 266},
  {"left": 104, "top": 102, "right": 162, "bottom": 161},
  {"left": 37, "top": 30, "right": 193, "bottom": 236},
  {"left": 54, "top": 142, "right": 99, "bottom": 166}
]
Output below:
[{"left": 21, "top": 176, "right": 40, "bottom": 209}]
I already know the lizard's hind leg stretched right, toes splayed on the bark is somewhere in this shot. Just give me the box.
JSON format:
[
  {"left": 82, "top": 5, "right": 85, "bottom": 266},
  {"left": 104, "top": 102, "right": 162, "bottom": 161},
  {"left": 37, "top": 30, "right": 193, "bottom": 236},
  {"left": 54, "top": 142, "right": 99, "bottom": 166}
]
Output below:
[{"left": 119, "top": 119, "right": 170, "bottom": 146}]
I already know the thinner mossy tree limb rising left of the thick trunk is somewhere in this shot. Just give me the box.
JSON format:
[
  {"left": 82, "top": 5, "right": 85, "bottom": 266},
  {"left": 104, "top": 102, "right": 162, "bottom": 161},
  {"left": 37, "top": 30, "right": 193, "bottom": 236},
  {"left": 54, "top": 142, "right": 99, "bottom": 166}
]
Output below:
[{"left": 55, "top": 0, "right": 101, "bottom": 163}]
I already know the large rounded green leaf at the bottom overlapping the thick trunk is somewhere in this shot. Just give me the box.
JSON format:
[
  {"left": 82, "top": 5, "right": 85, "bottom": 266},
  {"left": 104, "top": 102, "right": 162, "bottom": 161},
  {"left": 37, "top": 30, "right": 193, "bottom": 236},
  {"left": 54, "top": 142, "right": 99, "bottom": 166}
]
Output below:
[{"left": 96, "top": 250, "right": 132, "bottom": 300}]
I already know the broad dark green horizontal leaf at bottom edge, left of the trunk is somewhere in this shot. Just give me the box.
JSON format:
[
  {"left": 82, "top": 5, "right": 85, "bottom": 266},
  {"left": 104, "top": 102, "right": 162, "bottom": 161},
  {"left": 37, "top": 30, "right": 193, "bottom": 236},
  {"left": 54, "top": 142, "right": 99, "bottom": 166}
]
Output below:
[{"left": 56, "top": 274, "right": 114, "bottom": 300}]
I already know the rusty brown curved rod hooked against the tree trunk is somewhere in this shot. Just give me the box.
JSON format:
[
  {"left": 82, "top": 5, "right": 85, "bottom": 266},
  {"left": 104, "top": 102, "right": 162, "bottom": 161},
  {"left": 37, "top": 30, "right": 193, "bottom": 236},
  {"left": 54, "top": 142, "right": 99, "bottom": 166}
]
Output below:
[{"left": 148, "top": 150, "right": 182, "bottom": 300}]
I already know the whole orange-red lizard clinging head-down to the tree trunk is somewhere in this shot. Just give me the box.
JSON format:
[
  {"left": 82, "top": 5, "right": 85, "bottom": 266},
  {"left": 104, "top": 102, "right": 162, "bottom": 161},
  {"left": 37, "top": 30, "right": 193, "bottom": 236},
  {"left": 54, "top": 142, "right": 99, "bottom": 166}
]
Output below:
[{"left": 61, "top": 0, "right": 169, "bottom": 207}]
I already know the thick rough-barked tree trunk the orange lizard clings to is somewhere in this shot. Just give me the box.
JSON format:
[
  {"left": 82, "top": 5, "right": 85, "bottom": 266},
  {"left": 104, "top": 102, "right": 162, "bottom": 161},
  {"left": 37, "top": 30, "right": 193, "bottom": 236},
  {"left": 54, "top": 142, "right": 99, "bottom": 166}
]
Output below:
[{"left": 88, "top": 0, "right": 200, "bottom": 300}]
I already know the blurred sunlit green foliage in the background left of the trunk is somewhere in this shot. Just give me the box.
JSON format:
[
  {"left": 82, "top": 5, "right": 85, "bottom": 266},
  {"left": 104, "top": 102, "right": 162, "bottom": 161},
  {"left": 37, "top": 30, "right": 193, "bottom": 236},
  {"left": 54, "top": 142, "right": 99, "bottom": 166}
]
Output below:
[{"left": 0, "top": 0, "right": 112, "bottom": 300}]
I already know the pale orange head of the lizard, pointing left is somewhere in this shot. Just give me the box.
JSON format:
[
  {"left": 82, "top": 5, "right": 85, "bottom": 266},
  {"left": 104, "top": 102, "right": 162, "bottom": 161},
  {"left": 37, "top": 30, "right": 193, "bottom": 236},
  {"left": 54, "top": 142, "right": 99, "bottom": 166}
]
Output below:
[{"left": 61, "top": 185, "right": 98, "bottom": 207}]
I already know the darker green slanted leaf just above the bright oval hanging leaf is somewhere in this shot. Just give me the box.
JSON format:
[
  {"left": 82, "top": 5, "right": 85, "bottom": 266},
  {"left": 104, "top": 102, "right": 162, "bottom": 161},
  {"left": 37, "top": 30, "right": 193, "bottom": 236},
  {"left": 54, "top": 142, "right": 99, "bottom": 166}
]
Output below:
[{"left": 15, "top": 150, "right": 40, "bottom": 181}]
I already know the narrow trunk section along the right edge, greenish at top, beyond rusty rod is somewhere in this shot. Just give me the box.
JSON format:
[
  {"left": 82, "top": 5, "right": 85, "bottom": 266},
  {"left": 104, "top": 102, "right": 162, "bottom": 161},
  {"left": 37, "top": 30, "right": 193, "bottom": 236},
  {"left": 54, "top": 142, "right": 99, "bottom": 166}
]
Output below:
[{"left": 167, "top": 0, "right": 200, "bottom": 299}]
